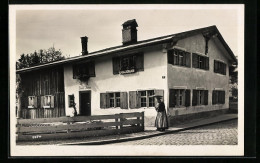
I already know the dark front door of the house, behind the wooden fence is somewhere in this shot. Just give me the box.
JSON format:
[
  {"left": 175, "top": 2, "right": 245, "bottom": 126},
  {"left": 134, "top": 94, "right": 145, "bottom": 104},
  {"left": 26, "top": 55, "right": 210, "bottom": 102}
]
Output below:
[{"left": 79, "top": 91, "right": 91, "bottom": 116}]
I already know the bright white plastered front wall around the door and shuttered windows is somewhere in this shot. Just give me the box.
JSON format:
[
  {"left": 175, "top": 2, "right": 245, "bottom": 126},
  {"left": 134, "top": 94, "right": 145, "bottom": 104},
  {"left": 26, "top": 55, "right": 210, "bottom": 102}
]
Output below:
[{"left": 64, "top": 46, "right": 168, "bottom": 125}]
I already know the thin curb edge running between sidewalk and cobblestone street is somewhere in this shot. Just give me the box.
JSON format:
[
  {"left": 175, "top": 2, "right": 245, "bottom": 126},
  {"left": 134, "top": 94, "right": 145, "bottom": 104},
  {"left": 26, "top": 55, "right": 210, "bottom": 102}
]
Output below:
[{"left": 59, "top": 117, "right": 238, "bottom": 145}]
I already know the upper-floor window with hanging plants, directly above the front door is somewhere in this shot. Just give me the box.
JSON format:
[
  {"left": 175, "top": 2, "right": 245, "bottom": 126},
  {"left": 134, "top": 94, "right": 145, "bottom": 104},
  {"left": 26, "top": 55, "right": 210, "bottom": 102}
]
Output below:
[{"left": 73, "top": 61, "right": 96, "bottom": 79}]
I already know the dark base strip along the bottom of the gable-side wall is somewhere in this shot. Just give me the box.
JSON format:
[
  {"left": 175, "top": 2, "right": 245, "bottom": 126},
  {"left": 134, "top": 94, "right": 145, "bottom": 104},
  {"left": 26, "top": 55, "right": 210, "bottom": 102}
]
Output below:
[{"left": 168, "top": 109, "right": 230, "bottom": 127}]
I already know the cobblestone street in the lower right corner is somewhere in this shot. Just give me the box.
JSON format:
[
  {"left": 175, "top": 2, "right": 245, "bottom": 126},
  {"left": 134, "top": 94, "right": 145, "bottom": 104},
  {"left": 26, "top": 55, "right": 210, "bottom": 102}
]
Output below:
[{"left": 110, "top": 120, "right": 237, "bottom": 145}]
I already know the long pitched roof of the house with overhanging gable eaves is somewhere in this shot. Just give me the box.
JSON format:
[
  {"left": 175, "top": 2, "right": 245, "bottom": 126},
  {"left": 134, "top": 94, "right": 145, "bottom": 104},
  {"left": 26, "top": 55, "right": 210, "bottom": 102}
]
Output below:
[{"left": 16, "top": 26, "right": 237, "bottom": 73}]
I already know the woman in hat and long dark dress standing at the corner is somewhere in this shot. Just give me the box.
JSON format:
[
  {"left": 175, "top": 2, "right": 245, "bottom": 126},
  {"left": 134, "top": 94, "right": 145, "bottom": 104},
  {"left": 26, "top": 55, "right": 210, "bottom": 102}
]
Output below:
[{"left": 154, "top": 96, "right": 168, "bottom": 131}]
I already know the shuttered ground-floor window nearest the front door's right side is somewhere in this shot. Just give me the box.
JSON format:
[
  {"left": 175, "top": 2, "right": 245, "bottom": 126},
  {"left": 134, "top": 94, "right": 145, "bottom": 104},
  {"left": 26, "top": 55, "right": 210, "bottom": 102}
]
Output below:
[{"left": 100, "top": 92, "right": 128, "bottom": 109}]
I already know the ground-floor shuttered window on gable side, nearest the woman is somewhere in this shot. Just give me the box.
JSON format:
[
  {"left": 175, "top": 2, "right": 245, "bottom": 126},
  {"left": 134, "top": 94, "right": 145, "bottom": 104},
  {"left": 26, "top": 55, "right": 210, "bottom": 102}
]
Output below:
[{"left": 169, "top": 89, "right": 190, "bottom": 107}]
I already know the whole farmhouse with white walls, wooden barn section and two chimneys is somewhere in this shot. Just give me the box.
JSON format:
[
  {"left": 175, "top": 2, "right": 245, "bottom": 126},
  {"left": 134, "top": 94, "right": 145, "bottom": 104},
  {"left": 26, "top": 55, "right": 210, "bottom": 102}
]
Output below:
[{"left": 16, "top": 20, "right": 237, "bottom": 126}]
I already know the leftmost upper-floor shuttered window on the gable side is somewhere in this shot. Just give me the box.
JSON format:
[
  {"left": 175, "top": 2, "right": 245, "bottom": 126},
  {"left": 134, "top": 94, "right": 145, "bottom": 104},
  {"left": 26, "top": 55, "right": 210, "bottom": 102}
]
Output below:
[{"left": 168, "top": 49, "right": 190, "bottom": 67}]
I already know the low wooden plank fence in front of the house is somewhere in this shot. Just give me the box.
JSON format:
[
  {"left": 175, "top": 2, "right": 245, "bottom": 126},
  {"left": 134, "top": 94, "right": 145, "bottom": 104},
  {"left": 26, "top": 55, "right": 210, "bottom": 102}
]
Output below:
[{"left": 16, "top": 112, "right": 144, "bottom": 141}]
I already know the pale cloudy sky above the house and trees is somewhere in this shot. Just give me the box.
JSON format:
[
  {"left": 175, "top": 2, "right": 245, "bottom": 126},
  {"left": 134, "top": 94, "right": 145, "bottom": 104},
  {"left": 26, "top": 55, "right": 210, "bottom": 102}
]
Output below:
[{"left": 16, "top": 6, "right": 240, "bottom": 58}]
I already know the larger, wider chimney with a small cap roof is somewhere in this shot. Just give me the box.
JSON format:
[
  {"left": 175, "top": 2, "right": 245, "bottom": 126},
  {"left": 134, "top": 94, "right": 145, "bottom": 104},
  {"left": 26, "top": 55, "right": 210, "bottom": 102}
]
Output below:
[{"left": 122, "top": 19, "right": 138, "bottom": 45}]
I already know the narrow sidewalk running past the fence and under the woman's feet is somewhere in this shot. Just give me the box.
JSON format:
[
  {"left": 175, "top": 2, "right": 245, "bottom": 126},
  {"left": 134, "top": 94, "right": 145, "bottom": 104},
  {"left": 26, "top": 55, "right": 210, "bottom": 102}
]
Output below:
[{"left": 59, "top": 114, "right": 238, "bottom": 145}]
